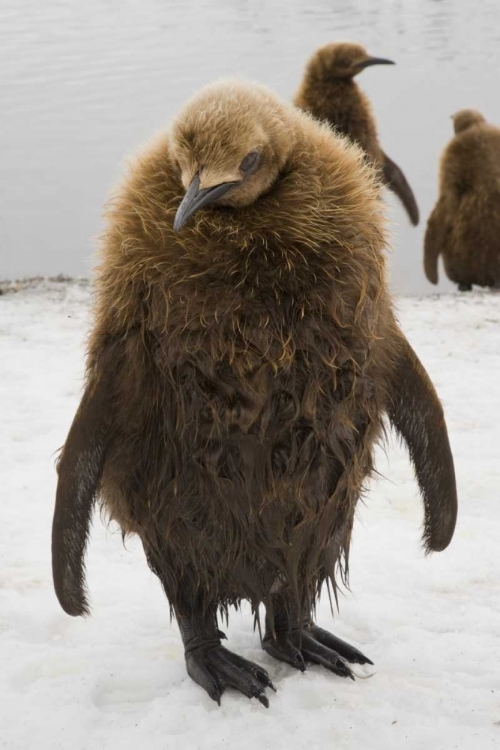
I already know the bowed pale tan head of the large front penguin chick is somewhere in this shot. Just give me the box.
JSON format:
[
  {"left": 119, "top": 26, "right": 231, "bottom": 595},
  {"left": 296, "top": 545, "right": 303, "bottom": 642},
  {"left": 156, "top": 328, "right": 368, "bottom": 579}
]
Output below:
[{"left": 171, "top": 80, "right": 295, "bottom": 232}]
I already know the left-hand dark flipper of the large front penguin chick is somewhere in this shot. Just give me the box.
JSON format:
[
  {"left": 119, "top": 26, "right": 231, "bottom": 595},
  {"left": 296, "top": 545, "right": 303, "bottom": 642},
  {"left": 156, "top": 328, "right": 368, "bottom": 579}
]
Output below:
[{"left": 52, "top": 346, "right": 116, "bottom": 617}]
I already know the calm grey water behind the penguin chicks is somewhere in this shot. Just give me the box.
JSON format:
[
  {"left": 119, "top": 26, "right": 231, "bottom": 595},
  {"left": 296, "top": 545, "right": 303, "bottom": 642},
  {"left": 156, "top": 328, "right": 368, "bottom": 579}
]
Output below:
[{"left": 0, "top": 0, "right": 500, "bottom": 294}]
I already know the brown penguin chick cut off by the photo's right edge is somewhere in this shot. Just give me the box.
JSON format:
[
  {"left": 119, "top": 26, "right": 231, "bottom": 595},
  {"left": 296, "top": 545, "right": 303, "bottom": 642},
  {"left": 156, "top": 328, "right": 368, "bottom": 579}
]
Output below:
[{"left": 424, "top": 109, "right": 500, "bottom": 291}]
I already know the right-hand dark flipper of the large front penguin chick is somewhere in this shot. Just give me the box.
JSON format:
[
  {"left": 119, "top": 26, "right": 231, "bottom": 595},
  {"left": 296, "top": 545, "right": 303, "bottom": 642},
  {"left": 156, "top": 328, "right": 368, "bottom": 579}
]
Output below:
[{"left": 387, "top": 333, "right": 457, "bottom": 552}]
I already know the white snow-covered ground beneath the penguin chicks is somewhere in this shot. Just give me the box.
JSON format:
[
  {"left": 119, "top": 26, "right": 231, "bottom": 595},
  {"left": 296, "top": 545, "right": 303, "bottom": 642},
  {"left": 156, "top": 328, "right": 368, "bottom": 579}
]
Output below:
[{"left": 0, "top": 283, "right": 500, "bottom": 750}]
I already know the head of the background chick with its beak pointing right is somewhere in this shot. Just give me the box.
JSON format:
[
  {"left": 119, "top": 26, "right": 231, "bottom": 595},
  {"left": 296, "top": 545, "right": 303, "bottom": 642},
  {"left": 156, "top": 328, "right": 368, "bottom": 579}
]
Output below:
[{"left": 308, "top": 42, "right": 395, "bottom": 79}]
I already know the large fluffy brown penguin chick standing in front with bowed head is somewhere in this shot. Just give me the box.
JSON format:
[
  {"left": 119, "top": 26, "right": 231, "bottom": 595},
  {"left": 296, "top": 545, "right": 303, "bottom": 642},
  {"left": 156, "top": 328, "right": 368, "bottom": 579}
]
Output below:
[{"left": 52, "top": 82, "right": 456, "bottom": 705}]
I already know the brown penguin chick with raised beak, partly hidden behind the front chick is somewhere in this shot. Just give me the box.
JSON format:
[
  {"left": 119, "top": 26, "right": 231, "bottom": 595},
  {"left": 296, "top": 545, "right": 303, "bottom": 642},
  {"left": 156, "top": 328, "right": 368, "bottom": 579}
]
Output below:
[{"left": 294, "top": 42, "right": 419, "bottom": 226}]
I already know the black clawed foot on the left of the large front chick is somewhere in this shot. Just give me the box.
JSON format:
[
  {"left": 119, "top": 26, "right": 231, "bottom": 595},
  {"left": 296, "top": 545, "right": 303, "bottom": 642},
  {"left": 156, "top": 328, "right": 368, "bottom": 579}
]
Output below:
[{"left": 186, "top": 642, "right": 276, "bottom": 708}]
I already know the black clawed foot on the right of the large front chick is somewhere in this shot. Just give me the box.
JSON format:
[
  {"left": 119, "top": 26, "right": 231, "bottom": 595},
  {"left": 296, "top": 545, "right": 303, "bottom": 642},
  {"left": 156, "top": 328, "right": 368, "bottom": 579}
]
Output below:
[{"left": 262, "top": 624, "right": 373, "bottom": 680}]
